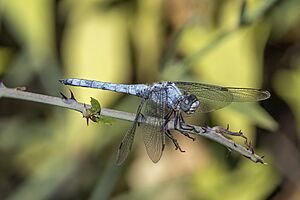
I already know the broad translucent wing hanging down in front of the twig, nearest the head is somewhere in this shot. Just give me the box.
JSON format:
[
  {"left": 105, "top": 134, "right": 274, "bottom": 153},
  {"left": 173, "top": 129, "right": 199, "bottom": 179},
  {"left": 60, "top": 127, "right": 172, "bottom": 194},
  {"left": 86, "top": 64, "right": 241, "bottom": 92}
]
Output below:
[{"left": 139, "top": 90, "right": 167, "bottom": 163}]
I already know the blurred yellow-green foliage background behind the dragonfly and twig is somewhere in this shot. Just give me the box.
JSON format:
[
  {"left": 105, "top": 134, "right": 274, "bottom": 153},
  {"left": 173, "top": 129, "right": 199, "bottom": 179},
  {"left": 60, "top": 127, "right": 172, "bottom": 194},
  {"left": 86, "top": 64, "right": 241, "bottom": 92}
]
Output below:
[{"left": 0, "top": 0, "right": 300, "bottom": 200}]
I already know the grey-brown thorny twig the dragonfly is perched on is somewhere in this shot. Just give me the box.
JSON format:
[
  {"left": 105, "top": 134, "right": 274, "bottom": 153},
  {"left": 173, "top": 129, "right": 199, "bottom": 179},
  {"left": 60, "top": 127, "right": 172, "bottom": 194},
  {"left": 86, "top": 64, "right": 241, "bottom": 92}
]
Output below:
[{"left": 0, "top": 82, "right": 264, "bottom": 164}]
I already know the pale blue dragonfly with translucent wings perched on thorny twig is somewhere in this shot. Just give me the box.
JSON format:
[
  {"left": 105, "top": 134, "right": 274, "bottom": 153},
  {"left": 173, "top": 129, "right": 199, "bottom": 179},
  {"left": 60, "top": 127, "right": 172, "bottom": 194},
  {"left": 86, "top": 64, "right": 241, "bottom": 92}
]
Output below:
[{"left": 60, "top": 78, "right": 270, "bottom": 165}]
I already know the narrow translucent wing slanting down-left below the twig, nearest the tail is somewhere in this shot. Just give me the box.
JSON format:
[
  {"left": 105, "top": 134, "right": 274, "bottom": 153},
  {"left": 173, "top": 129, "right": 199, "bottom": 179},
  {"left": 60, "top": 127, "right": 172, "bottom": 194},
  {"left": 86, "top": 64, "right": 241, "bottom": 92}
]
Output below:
[{"left": 116, "top": 99, "right": 145, "bottom": 165}]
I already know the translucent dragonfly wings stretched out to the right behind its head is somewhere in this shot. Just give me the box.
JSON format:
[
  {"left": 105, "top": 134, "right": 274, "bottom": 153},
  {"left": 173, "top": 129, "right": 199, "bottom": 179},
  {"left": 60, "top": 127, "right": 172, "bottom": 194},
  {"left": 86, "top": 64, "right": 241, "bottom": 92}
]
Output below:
[{"left": 175, "top": 82, "right": 270, "bottom": 112}]
